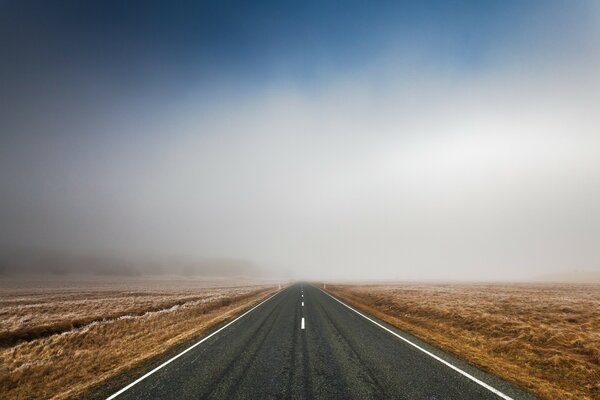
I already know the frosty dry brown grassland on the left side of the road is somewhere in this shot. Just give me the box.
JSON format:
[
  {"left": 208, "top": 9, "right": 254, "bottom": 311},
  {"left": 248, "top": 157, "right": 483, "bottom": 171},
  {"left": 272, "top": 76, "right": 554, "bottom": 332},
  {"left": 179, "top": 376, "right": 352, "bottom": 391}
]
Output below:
[{"left": 0, "top": 280, "right": 275, "bottom": 399}]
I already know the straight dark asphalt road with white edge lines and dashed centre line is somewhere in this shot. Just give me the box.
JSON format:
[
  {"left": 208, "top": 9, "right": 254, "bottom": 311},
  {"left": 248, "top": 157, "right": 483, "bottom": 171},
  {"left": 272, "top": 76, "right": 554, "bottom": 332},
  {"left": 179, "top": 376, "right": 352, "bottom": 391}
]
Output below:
[{"left": 105, "top": 284, "right": 533, "bottom": 400}]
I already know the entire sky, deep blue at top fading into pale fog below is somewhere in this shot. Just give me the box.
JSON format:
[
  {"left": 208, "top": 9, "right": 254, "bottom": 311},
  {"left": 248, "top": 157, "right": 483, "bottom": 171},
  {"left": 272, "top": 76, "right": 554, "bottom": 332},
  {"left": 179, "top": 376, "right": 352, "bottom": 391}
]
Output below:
[{"left": 0, "top": 0, "right": 600, "bottom": 280}]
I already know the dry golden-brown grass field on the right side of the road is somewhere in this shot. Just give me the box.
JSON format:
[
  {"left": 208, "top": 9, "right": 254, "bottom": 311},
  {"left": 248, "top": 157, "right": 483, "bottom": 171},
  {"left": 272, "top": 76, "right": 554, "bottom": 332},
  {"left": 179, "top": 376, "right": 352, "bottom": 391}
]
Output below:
[{"left": 327, "top": 284, "right": 600, "bottom": 400}]
